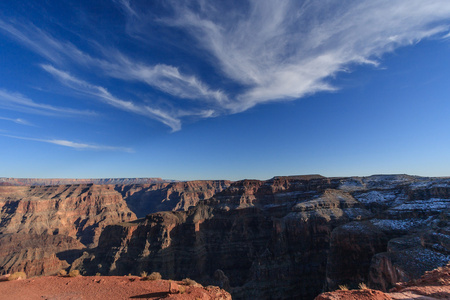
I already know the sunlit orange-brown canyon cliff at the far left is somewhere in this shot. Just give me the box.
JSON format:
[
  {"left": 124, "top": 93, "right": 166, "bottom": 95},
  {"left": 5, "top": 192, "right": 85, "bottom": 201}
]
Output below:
[{"left": 0, "top": 184, "right": 136, "bottom": 276}]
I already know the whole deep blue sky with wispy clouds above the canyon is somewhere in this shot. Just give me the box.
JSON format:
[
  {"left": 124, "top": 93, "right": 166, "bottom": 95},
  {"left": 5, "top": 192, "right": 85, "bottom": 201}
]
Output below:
[{"left": 0, "top": 0, "right": 450, "bottom": 180}]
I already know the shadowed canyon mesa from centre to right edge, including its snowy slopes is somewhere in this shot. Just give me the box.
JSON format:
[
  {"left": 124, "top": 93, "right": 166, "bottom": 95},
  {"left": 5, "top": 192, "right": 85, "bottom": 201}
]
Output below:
[{"left": 78, "top": 175, "right": 450, "bottom": 299}]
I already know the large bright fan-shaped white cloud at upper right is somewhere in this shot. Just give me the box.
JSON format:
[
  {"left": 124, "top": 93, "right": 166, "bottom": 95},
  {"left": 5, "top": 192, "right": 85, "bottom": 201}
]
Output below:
[{"left": 163, "top": 0, "right": 450, "bottom": 112}]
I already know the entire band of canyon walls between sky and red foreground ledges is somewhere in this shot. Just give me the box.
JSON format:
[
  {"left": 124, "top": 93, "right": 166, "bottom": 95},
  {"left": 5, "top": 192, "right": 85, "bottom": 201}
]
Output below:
[{"left": 0, "top": 175, "right": 450, "bottom": 299}]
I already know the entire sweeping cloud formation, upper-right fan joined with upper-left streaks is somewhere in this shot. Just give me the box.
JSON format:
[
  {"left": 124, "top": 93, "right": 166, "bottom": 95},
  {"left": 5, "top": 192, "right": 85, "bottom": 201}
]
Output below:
[{"left": 0, "top": 0, "right": 450, "bottom": 131}]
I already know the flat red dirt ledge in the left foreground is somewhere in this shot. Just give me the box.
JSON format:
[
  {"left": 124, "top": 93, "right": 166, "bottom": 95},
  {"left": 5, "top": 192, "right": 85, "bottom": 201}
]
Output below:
[{"left": 0, "top": 276, "right": 231, "bottom": 300}]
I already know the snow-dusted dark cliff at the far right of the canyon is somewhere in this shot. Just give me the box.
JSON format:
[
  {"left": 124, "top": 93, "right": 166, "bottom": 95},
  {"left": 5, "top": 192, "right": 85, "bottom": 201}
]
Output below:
[{"left": 327, "top": 176, "right": 450, "bottom": 291}]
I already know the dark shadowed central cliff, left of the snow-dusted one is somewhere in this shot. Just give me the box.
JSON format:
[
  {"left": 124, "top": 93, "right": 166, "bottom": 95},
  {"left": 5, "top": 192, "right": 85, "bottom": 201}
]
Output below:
[{"left": 82, "top": 178, "right": 372, "bottom": 299}]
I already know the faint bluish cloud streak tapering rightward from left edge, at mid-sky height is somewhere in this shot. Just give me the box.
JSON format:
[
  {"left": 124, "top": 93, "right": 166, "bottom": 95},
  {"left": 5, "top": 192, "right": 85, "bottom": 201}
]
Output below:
[{"left": 0, "top": 89, "right": 97, "bottom": 116}]
